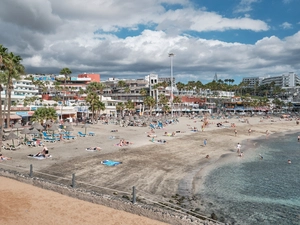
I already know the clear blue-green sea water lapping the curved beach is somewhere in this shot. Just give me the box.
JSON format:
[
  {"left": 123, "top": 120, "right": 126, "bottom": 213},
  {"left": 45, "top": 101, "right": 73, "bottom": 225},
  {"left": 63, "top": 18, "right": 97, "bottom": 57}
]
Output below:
[{"left": 199, "top": 134, "right": 300, "bottom": 225}]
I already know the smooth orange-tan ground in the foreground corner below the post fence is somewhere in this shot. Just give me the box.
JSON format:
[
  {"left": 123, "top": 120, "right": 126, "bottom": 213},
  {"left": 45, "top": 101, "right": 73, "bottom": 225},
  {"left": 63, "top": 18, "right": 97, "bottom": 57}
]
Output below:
[{"left": 0, "top": 177, "right": 166, "bottom": 225}]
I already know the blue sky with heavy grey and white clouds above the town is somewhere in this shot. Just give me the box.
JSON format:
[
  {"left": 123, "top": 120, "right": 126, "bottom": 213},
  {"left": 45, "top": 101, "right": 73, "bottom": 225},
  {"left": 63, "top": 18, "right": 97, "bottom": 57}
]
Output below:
[{"left": 0, "top": 0, "right": 300, "bottom": 83}]
